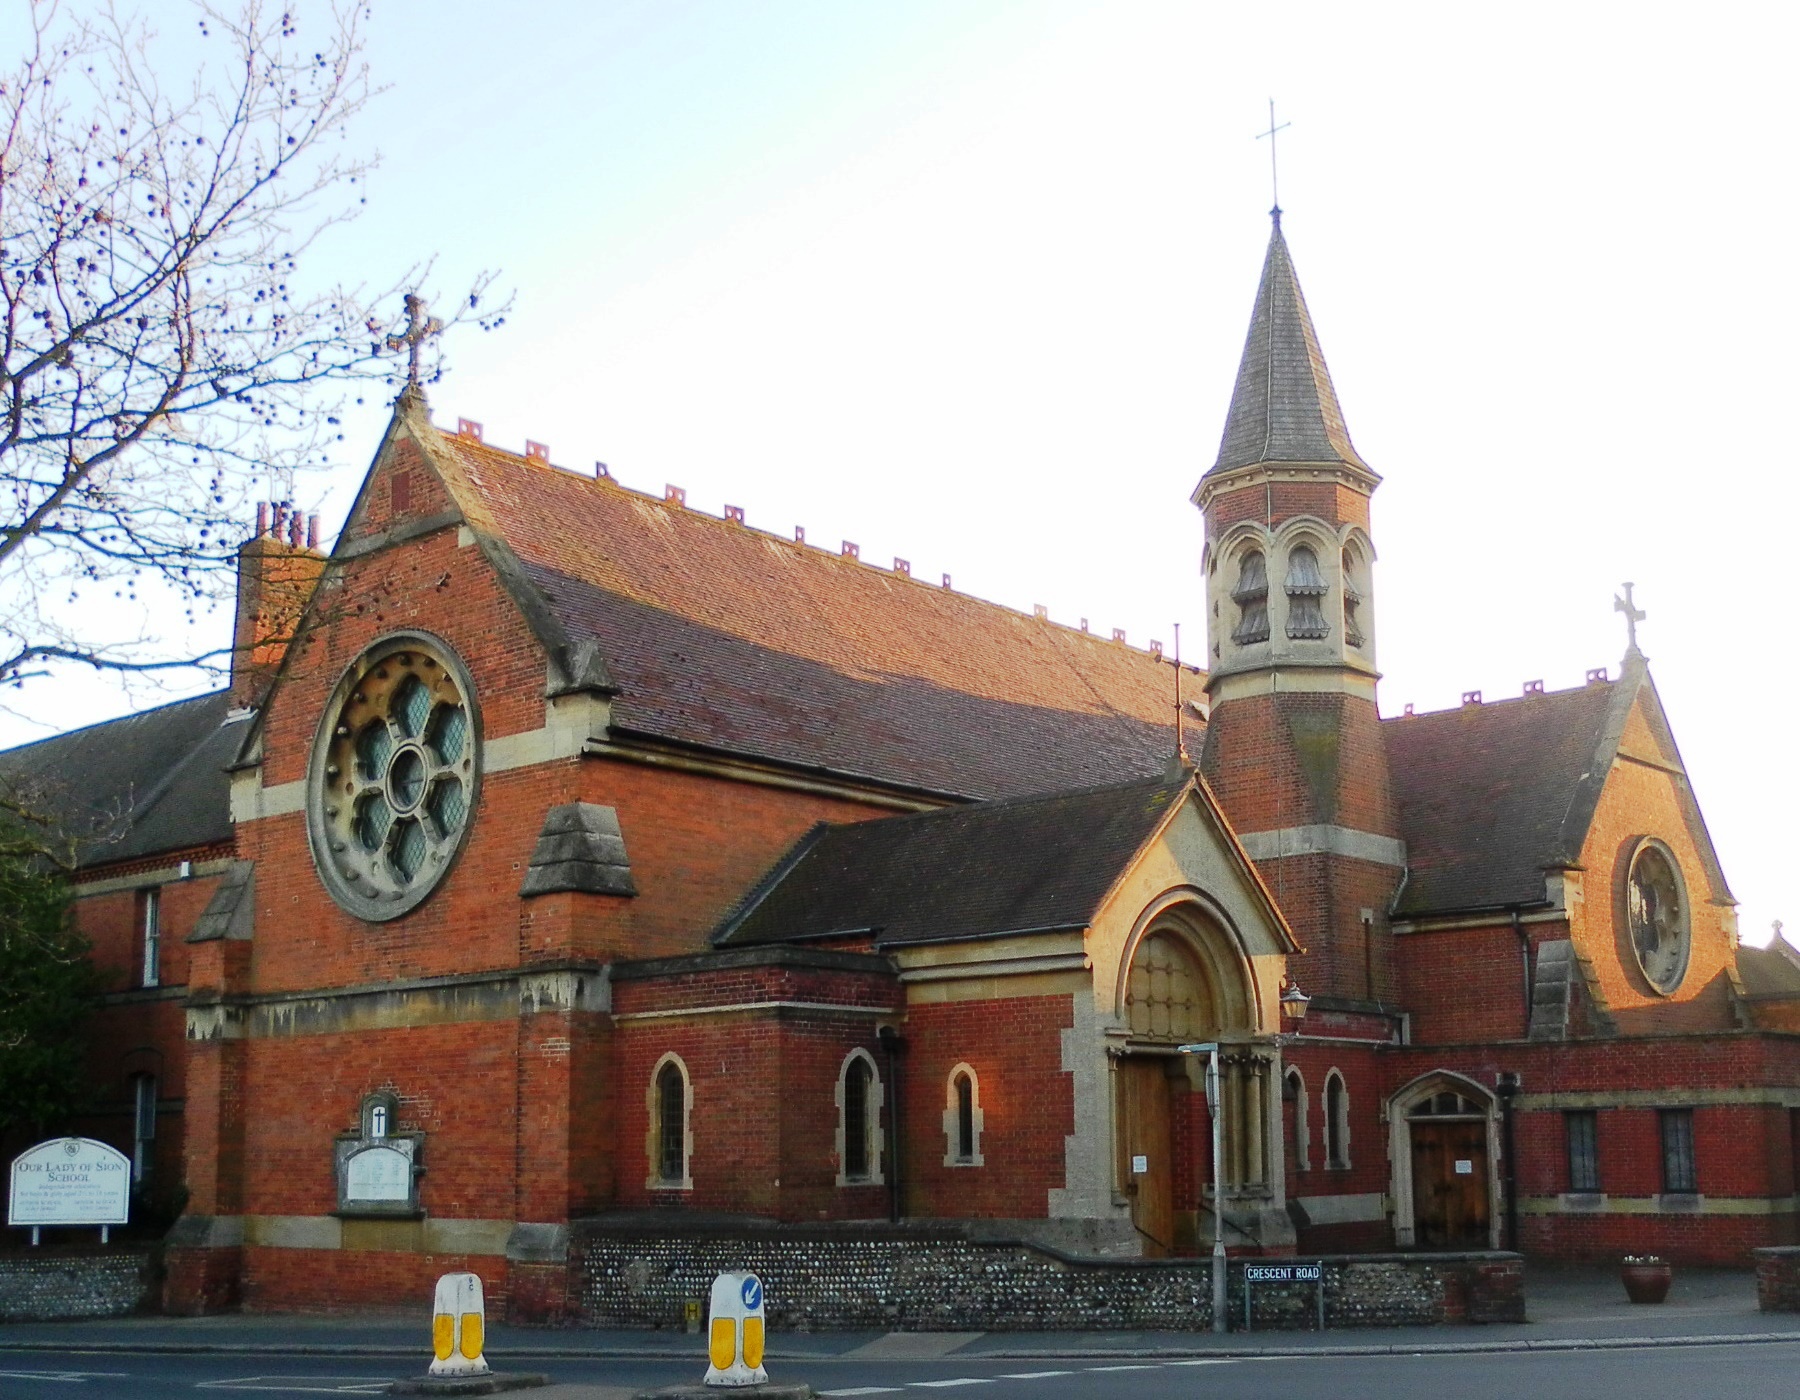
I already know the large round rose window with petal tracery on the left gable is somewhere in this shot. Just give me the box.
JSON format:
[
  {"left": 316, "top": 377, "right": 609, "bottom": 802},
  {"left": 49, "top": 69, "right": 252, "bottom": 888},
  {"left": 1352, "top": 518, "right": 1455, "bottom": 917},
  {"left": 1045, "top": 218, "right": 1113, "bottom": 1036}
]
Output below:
[{"left": 306, "top": 633, "right": 479, "bottom": 920}]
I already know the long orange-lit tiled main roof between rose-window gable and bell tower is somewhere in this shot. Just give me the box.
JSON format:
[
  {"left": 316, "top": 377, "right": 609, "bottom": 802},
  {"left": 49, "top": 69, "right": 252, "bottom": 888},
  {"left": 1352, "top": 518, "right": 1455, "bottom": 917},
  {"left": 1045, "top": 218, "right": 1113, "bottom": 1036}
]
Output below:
[{"left": 421, "top": 423, "right": 1199, "bottom": 797}]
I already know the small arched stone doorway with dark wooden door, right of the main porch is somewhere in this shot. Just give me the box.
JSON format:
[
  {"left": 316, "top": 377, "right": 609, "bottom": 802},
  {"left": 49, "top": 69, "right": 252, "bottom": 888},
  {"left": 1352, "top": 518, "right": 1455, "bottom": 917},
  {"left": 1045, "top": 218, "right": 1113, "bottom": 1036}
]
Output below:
[{"left": 1386, "top": 1069, "right": 1503, "bottom": 1249}]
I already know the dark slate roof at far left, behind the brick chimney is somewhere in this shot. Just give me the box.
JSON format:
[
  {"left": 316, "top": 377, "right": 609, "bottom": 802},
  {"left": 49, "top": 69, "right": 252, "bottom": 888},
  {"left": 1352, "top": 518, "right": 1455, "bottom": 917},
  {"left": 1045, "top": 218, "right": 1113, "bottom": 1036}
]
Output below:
[{"left": 0, "top": 691, "right": 243, "bottom": 866}]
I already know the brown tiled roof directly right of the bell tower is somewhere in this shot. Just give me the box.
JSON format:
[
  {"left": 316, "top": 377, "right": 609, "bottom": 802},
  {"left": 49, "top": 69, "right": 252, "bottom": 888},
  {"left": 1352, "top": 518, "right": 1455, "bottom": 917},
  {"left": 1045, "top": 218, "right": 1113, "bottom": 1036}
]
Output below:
[{"left": 1381, "top": 680, "right": 1636, "bottom": 916}]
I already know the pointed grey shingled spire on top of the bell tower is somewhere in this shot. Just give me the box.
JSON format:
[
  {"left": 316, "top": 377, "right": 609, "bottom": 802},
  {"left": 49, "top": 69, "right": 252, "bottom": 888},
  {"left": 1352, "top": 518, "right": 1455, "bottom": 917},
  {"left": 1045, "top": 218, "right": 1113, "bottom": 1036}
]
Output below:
[{"left": 1208, "top": 217, "right": 1373, "bottom": 475}]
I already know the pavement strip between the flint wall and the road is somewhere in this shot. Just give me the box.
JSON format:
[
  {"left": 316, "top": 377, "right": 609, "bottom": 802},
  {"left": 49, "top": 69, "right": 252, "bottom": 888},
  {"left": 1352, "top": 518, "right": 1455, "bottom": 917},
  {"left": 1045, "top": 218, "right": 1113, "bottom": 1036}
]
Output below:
[{"left": 0, "top": 1267, "right": 1800, "bottom": 1368}]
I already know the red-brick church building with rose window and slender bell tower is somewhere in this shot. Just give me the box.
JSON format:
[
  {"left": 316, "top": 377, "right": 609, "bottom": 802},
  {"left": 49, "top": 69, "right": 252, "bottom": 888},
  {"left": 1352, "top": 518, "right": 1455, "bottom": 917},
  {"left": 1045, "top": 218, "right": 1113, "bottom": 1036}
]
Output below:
[{"left": 14, "top": 216, "right": 1800, "bottom": 1321}]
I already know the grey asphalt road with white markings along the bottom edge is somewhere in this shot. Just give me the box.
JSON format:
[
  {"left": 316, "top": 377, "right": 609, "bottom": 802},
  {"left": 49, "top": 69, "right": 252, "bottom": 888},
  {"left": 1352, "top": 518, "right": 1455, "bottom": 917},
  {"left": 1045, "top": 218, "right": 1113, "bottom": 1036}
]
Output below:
[{"left": 0, "top": 1342, "right": 1800, "bottom": 1400}]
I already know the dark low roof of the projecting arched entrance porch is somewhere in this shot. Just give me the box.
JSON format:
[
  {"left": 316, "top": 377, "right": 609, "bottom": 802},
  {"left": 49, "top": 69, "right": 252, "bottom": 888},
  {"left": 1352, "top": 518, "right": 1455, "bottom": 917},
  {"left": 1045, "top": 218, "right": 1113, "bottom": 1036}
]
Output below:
[{"left": 713, "top": 779, "right": 1188, "bottom": 948}]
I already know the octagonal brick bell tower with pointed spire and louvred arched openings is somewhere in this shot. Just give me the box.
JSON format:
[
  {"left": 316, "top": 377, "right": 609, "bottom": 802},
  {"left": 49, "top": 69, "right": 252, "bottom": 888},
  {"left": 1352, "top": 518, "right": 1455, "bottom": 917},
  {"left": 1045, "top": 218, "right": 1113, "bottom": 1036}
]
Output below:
[{"left": 1193, "top": 211, "right": 1406, "bottom": 1001}]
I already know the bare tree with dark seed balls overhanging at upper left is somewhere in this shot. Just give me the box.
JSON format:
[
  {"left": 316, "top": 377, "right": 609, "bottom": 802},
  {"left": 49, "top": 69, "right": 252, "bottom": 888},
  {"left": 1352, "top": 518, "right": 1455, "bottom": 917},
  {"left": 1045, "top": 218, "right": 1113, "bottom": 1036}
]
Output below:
[{"left": 0, "top": 0, "right": 493, "bottom": 684}]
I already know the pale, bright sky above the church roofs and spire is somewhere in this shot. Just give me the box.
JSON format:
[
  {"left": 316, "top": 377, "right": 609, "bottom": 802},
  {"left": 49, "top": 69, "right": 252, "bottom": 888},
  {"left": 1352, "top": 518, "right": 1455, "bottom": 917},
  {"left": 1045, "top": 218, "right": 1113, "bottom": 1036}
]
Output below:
[{"left": 0, "top": 0, "right": 1800, "bottom": 941}]
